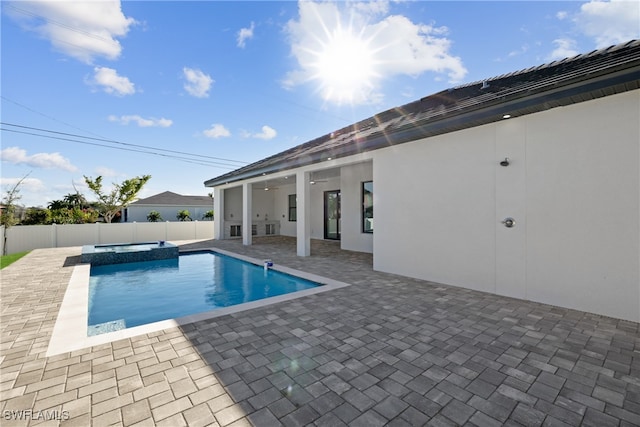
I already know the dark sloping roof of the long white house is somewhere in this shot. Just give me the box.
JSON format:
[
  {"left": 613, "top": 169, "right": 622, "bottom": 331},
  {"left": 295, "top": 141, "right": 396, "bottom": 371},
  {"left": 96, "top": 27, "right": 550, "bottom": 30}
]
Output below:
[{"left": 204, "top": 40, "right": 640, "bottom": 187}]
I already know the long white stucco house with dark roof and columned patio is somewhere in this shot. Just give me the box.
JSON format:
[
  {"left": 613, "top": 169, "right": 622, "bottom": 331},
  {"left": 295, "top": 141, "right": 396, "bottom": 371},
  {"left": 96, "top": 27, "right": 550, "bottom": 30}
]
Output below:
[{"left": 205, "top": 41, "right": 640, "bottom": 322}]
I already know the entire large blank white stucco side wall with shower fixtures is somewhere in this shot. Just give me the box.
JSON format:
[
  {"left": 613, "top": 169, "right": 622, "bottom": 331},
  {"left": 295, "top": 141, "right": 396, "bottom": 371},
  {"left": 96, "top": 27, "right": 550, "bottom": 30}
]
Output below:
[{"left": 373, "top": 91, "right": 640, "bottom": 321}]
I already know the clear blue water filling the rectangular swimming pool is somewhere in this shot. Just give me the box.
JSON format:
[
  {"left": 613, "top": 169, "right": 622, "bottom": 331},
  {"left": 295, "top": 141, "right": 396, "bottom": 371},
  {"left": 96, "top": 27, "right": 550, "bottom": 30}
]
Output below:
[{"left": 88, "top": 252, "right": 320, "bottom": 336}]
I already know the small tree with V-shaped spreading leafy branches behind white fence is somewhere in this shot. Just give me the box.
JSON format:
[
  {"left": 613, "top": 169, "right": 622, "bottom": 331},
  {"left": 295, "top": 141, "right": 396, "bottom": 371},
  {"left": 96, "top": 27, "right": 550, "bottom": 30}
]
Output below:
[{"left": 84, "top": 175, "right": 151, "bottom": 223}]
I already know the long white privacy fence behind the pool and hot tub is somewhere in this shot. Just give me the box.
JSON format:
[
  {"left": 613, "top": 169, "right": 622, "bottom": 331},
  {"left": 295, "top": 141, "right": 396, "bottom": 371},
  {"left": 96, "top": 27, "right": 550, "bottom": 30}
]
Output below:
[{"left": 0, "top": 221, "right": 213, "bottom": 254}]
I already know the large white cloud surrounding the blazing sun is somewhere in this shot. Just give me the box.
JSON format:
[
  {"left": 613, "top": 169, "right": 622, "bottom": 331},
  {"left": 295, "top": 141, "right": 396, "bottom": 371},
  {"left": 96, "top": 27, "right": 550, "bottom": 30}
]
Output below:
[{"left": 282, "top": 1, "right": 467, "bottom": 104}]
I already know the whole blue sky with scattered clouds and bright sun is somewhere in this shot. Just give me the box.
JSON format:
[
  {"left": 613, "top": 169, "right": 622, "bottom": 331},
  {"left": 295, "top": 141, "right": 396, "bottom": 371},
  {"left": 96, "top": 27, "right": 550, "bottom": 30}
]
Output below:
[{"left": 1, "top": 1, "right": 640, "bottom": 206}]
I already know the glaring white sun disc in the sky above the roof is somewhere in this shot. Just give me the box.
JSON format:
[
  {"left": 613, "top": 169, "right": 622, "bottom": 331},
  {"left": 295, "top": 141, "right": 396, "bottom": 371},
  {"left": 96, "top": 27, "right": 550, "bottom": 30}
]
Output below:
[{"left": 314, "top": 28, "right": 376, "bottom": 104}]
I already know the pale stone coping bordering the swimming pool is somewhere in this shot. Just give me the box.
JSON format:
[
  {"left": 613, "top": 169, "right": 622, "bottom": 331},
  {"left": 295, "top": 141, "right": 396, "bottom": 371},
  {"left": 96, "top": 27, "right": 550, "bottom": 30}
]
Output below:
[{"left": 46, "top": 248, "right": 350, "bottom": 357}]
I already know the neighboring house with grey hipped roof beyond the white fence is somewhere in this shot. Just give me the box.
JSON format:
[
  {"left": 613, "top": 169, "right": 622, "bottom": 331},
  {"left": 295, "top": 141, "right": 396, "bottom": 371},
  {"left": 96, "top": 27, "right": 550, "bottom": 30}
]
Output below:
[{"left": 123, "top": 191, "right": 213, "bottom": 222}]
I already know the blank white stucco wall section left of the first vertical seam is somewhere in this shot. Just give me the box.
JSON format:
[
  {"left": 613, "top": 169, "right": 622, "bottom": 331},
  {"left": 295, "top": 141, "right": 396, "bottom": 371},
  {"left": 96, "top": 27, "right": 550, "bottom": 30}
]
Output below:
[{"left": 373, "top": 126, "right": 496, "bottom": 292}]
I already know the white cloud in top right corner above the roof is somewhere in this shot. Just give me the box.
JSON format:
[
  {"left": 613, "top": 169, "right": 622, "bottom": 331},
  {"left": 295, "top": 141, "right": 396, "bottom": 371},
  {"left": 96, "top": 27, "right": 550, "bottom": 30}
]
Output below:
[{"left": 575, "top": 0, "right": 640, "bottom": 48}]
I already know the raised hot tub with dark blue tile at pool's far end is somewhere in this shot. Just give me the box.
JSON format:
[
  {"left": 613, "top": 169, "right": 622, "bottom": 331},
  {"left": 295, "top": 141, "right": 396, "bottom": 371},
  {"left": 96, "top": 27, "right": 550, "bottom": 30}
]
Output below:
[{"left": 80, "top": 240, "right": 178, "bottom": 265}]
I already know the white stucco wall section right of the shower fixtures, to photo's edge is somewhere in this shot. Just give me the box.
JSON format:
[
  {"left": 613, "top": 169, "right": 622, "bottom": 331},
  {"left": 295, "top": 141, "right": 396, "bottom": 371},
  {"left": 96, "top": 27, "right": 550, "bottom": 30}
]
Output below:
[{"left": 527, "top": 91, "right": 640, "bottom": 321}]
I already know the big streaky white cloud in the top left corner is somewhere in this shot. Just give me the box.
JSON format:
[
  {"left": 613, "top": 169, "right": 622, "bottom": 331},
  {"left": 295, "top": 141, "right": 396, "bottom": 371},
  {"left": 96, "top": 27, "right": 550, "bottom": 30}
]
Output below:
[{"left": 3, "top": 0, "right": 136, "bottom": 64}]
